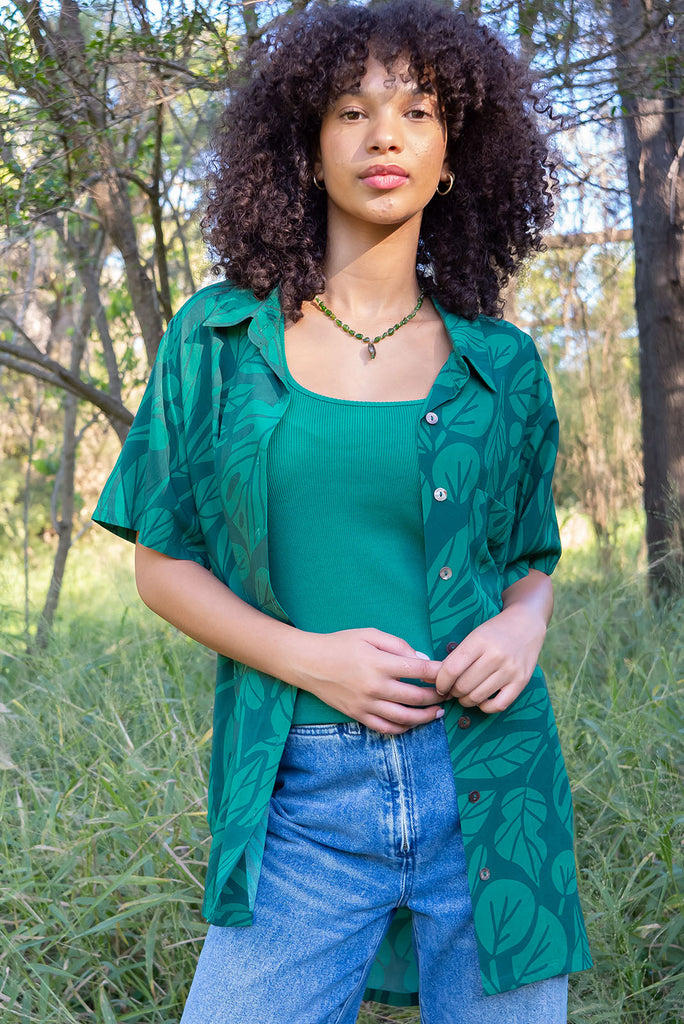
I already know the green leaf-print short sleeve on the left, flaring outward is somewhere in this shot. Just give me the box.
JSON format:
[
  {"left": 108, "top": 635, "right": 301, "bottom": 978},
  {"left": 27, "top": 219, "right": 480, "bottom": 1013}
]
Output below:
[{"left": 93, "top": 321, "right": 209, "bottom": 566}]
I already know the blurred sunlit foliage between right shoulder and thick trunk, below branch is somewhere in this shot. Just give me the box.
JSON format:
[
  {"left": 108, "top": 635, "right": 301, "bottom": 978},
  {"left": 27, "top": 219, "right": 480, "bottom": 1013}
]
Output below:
[{"left": 517, "top": 244, "right": 642, "bottom": 563}]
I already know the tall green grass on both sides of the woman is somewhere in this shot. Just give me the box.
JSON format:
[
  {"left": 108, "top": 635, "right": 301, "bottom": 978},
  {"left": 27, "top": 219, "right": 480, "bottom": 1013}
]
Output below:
[{"left": 0, "top": 538, "right": 684, "bottom": 1024}]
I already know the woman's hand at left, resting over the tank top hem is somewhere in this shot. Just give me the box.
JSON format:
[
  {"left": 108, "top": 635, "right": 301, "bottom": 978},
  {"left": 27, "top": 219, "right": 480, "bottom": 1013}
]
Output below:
[{"left": 290, "top": 629, "right": 444, "bottom": 735}]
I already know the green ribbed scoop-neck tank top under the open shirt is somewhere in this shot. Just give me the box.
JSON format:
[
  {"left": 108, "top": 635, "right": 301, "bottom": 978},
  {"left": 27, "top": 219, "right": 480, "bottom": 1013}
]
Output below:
[{"left": 267, "top": 378, "right": 432, "bottom": 724}]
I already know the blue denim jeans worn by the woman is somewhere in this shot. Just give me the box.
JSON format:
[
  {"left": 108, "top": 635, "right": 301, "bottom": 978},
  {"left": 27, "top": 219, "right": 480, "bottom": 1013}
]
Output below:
[{"left": 181, "top": 721, "right": 567, "bottom": 1024}]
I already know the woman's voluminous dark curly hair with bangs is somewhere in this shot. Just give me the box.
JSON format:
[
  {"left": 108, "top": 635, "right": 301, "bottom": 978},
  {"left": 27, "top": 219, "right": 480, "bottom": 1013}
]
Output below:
[{"left": 202, "top": 0, "right": 556, "bottom": 321}]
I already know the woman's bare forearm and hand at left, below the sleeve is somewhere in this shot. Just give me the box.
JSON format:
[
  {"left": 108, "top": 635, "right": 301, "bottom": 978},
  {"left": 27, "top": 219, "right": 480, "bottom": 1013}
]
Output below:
[{"left": 135, "top": 543, "right": 442, "bottom": 733}]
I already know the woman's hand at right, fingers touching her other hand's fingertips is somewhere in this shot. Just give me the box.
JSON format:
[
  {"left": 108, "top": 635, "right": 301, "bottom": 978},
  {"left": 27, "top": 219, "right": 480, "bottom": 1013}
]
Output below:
[{"left": 435, "top": 605, "right": 546, "bottom": 714}]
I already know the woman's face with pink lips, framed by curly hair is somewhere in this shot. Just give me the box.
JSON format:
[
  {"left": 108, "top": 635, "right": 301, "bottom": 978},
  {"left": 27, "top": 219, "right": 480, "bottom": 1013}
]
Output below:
[{"left": 314, "top": 57, "right": 448, "bottom": 225}]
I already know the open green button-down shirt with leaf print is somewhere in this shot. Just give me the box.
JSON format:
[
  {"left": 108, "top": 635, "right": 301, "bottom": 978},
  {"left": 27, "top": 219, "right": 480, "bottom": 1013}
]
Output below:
[{"left": 93, "top": 283, "right": 591, "bottom": 1005}]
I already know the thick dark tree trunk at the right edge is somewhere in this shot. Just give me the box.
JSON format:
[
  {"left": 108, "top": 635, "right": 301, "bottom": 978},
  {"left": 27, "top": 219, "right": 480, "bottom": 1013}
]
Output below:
[{"left": 611, "top": 0, "right": 684, "bottom": 600}]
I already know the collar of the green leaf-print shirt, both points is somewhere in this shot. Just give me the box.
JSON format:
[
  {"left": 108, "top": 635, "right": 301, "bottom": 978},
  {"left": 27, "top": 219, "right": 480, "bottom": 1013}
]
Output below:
[{"left": 204, "top": 282, "right": 496, "bottom": 391}]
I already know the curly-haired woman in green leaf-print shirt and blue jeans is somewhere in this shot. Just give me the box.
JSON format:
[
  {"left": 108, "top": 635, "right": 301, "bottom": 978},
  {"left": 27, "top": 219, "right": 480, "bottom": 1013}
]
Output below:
[{"left": 95, "top": 0, "right": 591, "bottom": 1024}]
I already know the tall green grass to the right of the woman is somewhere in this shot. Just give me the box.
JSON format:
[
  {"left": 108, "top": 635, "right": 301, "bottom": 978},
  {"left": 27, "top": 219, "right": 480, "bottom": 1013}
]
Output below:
[{"left": 545, "top": 567, "right": 684, "bottom": 1024}]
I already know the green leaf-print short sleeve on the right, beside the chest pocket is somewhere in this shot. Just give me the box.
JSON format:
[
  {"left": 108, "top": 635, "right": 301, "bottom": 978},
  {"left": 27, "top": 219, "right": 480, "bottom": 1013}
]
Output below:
[{"left": 503, "top": 350, "right": 561, "bottom": 590}]
